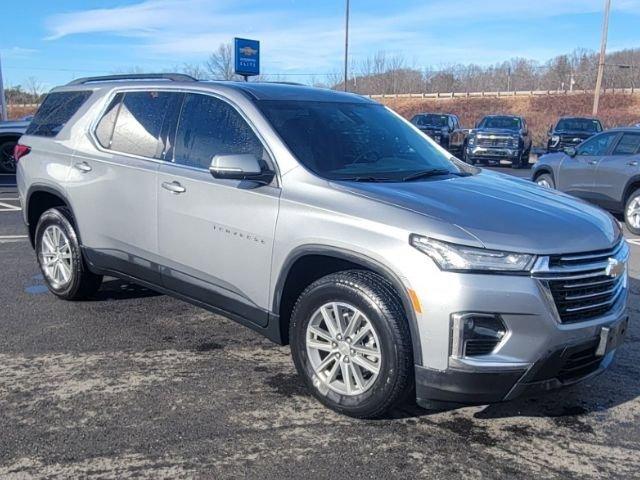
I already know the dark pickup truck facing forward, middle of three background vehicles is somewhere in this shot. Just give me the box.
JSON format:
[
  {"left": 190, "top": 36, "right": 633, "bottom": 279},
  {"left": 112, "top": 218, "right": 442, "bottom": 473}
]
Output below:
[{"left": 463, "top": 115, "right": 531, "bottom": 168}]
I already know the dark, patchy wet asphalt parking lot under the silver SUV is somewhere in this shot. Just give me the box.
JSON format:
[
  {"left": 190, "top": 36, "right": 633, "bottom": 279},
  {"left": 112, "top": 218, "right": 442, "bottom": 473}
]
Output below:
[{"left": 0, "top": 169, "right": 640, "bottom": 479}]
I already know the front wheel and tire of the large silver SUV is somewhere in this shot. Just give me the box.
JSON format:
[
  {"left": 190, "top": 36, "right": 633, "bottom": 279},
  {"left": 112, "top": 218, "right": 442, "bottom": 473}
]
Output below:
[{"left": 289, "top": 270, "right": 414, "bottom": 418}]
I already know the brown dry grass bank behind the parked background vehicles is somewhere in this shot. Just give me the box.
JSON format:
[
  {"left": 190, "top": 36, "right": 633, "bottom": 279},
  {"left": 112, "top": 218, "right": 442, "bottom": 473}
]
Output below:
[{"left": 378, "top": 93, "right": 640, "bottom": 145}]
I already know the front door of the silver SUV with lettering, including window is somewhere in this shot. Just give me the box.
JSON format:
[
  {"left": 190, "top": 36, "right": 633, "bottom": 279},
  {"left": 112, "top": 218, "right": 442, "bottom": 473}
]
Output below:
[{"left": 156, "top": 93, "right": 280, "bottom": 325}]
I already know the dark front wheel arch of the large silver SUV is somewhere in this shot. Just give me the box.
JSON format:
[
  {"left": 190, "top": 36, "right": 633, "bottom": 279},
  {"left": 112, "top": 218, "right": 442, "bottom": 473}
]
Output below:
[{"left": 272, "top": 245, "right": 422, "bottom": 364}]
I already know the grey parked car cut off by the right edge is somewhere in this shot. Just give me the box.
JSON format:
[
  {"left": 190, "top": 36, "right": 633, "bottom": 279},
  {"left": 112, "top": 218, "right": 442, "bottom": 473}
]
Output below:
[{"left": 532, "top": 127, "right": 640, "bottom": 235}]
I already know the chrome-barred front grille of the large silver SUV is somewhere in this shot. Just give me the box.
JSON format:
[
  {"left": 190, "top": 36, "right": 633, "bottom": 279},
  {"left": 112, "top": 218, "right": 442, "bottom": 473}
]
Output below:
[{"left": 533, "top": 240, "right": 629, "bottom": 323}]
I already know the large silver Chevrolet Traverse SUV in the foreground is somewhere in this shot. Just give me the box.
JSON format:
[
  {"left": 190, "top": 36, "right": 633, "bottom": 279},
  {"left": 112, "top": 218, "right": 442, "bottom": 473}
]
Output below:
[{"left": 16, "top": 74, "right": 628, "bottom": 418}]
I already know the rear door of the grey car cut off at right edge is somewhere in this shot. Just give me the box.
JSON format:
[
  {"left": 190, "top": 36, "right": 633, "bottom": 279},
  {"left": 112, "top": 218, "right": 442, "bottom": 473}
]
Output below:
[{"left": 594, "top": 131, "right": 640, "bottom": 210}]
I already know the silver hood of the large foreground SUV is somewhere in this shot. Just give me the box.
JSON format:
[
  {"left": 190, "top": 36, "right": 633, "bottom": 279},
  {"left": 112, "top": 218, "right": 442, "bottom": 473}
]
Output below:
[{"left": 340, "top": 170, "right": 619, "bottom": 254}]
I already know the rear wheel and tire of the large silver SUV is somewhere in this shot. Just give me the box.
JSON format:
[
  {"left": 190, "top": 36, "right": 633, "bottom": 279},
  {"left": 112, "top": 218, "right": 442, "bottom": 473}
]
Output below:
[{"left": 35, "top": 207, "right": 102, "bottom": 300}]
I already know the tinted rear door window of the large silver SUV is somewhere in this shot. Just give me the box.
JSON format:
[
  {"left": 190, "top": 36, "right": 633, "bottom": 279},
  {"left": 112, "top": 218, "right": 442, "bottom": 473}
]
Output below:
[{"left": 111, "top": 91, "right": 175, "bottom": 158}]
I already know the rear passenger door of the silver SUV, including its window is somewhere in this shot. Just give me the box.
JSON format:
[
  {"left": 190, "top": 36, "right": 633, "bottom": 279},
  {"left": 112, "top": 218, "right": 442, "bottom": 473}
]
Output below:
[{"left": 67, "top": 91, "right": 176, "bottom": 283}]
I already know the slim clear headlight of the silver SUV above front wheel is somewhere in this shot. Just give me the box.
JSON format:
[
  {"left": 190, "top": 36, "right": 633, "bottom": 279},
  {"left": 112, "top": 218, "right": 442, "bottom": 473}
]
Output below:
[{"left": 409, "top": 234, "right": 535, "bottom": 272}]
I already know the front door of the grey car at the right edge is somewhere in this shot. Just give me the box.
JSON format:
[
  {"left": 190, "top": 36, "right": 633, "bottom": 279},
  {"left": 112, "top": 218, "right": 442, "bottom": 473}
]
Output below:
[{"left": 556, "top": 132, "right": 618, "bottom": 200}]
